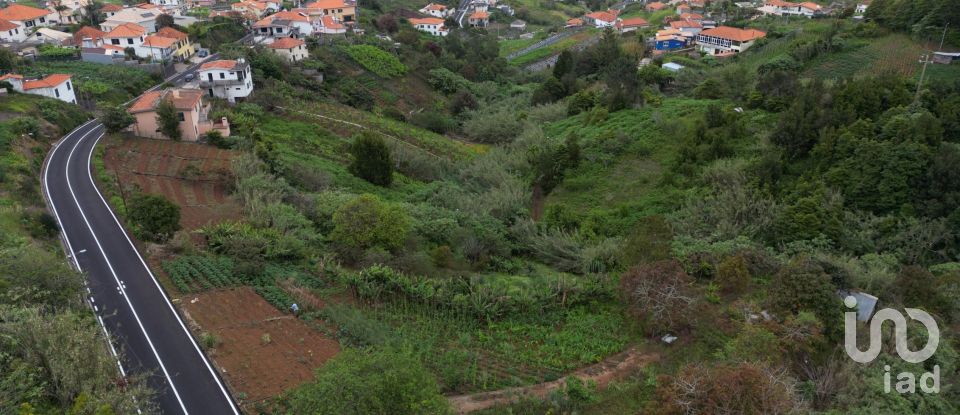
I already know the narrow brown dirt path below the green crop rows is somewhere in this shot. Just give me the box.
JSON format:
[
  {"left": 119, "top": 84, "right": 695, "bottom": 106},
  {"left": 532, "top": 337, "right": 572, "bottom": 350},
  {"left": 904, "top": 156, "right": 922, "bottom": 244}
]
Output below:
[{"left": 447, "top": 347, "right": 660, "bottom": 414}]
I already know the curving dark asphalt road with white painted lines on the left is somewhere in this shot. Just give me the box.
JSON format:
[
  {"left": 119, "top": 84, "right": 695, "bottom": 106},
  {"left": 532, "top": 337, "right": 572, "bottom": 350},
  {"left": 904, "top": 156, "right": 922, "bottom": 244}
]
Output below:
[{"left": 42, "top": 120, "right": 239, "bottom": 415}]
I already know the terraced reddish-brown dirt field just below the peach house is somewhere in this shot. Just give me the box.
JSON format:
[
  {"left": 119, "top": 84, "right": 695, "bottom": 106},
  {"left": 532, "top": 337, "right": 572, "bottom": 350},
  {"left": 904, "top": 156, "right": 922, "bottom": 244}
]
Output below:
[{"left": 104, "top": 138, "right": 240, "bottom": 230}]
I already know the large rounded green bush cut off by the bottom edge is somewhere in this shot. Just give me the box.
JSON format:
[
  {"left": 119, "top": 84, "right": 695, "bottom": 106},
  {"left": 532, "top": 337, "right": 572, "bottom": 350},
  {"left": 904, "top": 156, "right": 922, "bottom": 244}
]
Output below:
[{"left": 289, "top": 350, "right": 450, "bottom": 415}]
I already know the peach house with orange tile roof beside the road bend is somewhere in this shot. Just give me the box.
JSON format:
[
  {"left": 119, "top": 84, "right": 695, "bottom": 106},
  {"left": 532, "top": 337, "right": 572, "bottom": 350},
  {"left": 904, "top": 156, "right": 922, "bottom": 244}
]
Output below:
[{"left": 127, "top": 88, "right": 230, "bottom": 141}]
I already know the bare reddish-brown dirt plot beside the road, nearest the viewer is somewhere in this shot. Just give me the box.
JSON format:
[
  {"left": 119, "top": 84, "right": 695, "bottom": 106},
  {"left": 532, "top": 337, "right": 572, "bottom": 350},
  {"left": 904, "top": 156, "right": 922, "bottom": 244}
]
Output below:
[{"left": 180, "top": 287, "right": 340, "bottom": 409}]
